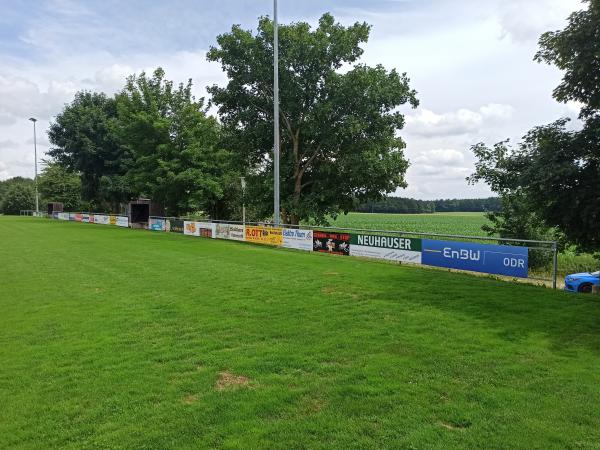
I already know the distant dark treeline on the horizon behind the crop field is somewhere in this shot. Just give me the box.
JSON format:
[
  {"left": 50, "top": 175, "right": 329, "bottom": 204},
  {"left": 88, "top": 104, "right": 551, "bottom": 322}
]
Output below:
[{"left": 355, "top": 197, "right": 501, "bottom": 214}]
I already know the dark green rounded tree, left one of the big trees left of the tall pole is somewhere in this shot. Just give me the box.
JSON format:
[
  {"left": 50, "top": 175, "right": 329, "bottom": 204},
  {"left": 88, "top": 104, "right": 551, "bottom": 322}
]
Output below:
[{"left": 48, "top": 92, "right": 132, "bottom": 209}]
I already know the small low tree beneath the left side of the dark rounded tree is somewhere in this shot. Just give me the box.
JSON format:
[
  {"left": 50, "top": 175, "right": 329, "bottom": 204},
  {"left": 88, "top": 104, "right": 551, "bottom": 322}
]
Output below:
[{"left": 38, "top": 163, "right": 81, "bottom": 211}]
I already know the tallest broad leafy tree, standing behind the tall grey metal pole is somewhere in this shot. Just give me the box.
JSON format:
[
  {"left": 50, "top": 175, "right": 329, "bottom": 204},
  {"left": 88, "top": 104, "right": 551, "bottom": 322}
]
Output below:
[{"left": 207, "top": 14, "right": 418, "bottom": 224}]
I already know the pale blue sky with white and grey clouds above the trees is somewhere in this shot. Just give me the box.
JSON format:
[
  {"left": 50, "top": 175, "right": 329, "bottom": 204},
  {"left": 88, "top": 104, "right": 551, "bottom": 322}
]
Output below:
[{"left": 0, "top": 0, "right": 582, "bottom": 199}]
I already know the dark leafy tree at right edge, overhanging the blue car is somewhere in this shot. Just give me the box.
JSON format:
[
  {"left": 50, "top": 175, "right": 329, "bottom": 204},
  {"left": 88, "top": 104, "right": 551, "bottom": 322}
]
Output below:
[{"left": 470, "top": 0, "right": 600, "bottom": 251}]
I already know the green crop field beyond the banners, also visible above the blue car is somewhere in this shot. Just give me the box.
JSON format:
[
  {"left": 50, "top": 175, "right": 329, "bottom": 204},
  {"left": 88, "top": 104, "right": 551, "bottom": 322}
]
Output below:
[{"left": 331, "top": 212, "right": 600, "bottom": 284}]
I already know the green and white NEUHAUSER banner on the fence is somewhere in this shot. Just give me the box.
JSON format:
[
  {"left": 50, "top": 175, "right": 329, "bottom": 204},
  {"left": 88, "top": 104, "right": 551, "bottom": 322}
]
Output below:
[{"left": 350, "top": 234, "right": 421, "bottom": 264}]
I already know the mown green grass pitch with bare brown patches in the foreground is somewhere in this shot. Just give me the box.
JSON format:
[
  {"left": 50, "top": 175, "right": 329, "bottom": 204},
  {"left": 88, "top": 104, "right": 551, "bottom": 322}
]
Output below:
[{"left": 0, "top": 217, "right": 600, "bottom": 449}]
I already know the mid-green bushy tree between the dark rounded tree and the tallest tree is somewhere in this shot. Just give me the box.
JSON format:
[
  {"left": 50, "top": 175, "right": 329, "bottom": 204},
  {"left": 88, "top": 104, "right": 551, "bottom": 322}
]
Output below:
[{"left": 116, "top": 68, "right": 237, "bottom": 217}]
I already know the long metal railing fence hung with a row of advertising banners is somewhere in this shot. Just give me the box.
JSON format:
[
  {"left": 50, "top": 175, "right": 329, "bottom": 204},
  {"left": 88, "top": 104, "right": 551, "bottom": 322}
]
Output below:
[{"left": 45, "top": 212, "right": 558, "bottom": 289}]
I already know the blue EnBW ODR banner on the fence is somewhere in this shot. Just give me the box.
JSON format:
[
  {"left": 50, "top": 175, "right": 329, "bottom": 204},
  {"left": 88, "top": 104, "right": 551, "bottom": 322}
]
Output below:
[{"left": 422, "top": 239, "right": 529, "bottom": 278}]
